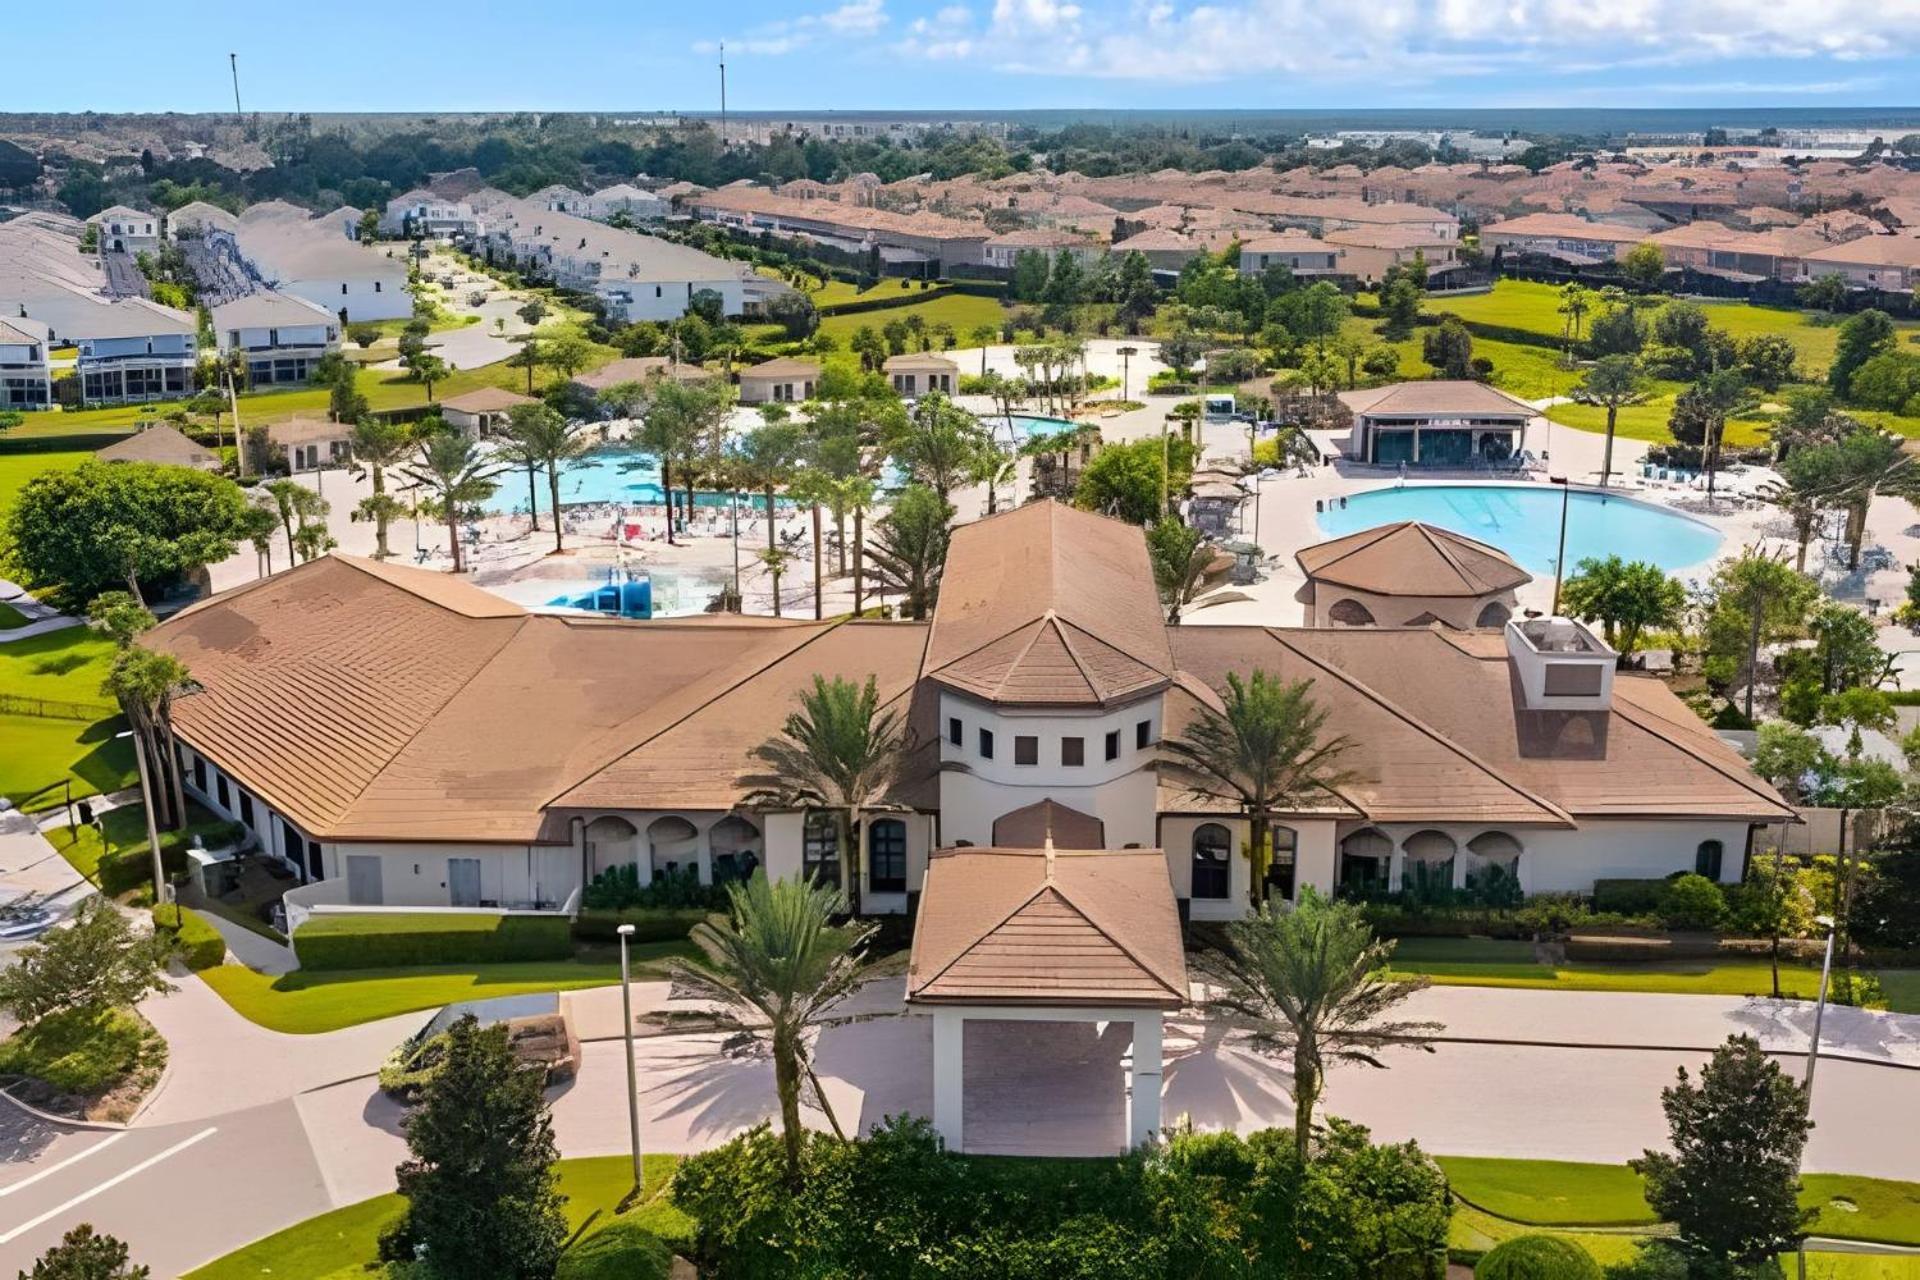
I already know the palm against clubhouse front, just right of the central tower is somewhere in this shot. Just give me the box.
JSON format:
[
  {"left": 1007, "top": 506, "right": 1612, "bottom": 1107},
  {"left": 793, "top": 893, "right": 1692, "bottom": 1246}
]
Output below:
[{"left": 1162, "top": 670, "right": 1354, "bottom": 906}]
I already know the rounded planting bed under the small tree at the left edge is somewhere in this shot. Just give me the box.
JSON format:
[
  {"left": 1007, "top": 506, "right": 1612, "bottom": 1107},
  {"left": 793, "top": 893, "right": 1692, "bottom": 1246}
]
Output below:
[{"left": 0, "top": 1009, "right": 167, "bottom": 1121}]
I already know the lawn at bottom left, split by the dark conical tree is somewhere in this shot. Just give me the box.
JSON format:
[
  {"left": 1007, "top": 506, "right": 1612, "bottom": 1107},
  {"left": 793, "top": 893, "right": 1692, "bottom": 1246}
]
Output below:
[{"left": 186, "top": 1155, "right": 693, "bottom": 1280}]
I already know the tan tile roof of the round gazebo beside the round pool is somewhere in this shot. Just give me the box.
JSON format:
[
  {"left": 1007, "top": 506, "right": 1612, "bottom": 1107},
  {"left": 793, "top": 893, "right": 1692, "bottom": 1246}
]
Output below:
[{"left": 1294, "top": 520, "right": 1534, "bottom": 597}]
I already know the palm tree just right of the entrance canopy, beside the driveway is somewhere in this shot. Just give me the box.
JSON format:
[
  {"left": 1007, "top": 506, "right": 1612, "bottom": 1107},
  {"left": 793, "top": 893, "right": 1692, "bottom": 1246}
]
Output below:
[{"left": 1194, "top": 889, "right": 1442, "bottom": 1165}]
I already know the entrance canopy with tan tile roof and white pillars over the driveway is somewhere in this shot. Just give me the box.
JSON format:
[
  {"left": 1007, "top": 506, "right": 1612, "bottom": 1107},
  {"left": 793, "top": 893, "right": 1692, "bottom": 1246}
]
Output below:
[{"left": 906, "top": 841, "right": 1187, "bottom": 1151}]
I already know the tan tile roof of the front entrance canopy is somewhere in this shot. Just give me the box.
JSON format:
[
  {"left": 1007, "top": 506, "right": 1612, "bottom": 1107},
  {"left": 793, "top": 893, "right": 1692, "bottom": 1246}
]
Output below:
[{"left": 906, "top": 848, "right": 1187, "bottom": 1009}]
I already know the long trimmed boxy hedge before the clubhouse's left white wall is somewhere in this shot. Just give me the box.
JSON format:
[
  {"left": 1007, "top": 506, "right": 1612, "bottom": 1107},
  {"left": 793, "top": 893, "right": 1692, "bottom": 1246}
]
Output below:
[{"left": 294, "top": 913, "right": 574, "bottom": 969}]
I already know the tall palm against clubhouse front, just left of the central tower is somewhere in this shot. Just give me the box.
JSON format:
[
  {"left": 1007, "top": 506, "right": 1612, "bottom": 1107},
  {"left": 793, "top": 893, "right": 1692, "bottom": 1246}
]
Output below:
[{"left": 747, "top": 676, "right": 906, "bottom": 915}]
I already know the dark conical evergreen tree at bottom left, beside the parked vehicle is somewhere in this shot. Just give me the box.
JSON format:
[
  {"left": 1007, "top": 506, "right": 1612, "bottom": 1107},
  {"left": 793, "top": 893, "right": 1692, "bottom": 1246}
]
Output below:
[{"left": 380, "top": 1013, "right": 566, "bottom": 1280}]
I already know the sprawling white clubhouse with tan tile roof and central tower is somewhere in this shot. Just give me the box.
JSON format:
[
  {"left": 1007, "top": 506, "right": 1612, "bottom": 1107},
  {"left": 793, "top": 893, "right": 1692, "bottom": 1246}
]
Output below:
[{"left": 144, "top": 501, "right": 1791, "bottom": 948}]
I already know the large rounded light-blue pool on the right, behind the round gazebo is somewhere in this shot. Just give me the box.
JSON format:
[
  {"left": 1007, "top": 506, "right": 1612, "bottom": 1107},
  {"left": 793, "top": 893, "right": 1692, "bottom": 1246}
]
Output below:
[{"left": 1319, "top": 484, "right": 1724, "bottom": 574}]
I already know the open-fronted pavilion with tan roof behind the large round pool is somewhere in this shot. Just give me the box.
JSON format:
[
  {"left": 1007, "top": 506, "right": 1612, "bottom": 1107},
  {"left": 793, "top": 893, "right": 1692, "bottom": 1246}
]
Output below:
[{"left": 1340, "top": 382, "right": 1540, "bottom": 466}]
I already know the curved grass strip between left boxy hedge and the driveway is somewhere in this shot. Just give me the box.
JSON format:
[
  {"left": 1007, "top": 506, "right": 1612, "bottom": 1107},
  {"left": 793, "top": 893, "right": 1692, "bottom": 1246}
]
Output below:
[{"left": 200, "top": 942, "right": 693, "bottom": 1036}]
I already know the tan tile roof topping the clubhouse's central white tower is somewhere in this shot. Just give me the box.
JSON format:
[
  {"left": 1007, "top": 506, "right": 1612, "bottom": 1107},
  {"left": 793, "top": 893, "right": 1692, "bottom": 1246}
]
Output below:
[{"left": 925, "top": 501, "right": 1173, "bottom": 704}]
